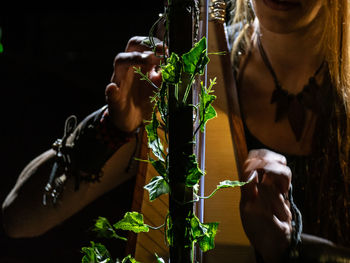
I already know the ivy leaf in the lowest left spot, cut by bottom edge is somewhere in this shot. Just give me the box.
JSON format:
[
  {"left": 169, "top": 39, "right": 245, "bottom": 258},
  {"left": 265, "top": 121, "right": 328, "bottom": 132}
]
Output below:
[{"left": 81, "top": 241, "right": 111, "bottom": 263}]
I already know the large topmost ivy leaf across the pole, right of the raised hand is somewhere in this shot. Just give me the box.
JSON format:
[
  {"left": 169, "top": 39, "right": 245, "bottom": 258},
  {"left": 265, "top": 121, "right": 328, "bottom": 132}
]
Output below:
[{"left": 182, "top": 37, "right": 209, "bottom": 75}]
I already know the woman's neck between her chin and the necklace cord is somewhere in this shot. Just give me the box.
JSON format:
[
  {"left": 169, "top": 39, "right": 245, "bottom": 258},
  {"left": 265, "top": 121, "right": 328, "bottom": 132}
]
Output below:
[{"left": 252, "top": 16, "right": 324, "bottom": 92}]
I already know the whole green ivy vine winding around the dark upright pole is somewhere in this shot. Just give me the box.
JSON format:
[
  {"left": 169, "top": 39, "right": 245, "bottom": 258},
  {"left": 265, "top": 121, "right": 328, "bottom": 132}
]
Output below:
[{"left": 82, "top": 1, "right": 249, "bottom": 263}]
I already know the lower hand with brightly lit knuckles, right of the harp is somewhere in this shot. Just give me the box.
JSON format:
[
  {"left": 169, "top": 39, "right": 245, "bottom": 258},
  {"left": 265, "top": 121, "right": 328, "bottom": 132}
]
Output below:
[{"left": 240, "top": 149, "right": 292, "bottom": 262}]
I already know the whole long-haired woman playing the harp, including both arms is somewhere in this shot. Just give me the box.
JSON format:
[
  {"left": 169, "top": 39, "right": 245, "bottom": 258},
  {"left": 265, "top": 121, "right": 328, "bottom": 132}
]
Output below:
[{"left": 3, "top": 0, "right": 350, "bottom": 262}]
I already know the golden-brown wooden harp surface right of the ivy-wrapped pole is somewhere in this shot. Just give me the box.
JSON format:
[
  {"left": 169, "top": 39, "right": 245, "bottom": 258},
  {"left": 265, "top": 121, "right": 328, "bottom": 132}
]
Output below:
[{"left": 204, "top": 19, "right": 255, "bottom": 263}]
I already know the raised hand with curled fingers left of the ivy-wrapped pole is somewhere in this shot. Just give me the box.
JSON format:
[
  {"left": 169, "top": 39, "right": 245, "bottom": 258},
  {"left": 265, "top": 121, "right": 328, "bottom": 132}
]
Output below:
[{"left": 105, "top": 37, "right": 167, "bottom": 132}]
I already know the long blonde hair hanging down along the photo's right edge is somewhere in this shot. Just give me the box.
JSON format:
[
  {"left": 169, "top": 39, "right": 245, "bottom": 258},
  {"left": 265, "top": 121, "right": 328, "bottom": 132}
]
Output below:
[{"left": 325, "top": 0, "right": 350, "bottom": 185}]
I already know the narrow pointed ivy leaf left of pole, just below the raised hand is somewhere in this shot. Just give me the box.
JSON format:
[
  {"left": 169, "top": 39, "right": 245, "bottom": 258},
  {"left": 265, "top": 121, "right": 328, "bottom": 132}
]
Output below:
[{"left": 145, "top": 111, "right": 164, "bottom": 161}]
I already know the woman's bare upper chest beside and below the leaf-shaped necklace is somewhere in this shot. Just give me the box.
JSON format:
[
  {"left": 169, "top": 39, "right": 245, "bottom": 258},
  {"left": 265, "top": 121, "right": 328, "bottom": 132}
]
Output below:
[{"left": 239, "top": 71, "right": 317, "bottom": 155}]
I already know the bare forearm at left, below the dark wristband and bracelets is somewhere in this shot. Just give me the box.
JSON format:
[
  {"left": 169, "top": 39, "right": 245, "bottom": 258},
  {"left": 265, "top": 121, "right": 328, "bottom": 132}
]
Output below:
[{"left": 3, "top": 107, "right": 140, "bottom": 237}]
